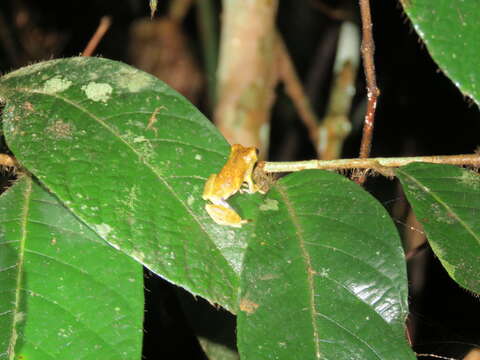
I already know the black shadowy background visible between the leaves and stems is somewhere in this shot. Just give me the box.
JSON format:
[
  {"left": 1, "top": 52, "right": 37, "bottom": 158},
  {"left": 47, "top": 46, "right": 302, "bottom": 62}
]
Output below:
[{"left": 0, "top": 0, "right": 480, "bottom": 359}]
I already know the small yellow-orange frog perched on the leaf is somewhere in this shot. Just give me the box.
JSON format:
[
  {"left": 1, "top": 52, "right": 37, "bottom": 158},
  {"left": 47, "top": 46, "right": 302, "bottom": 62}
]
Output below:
[{"left": 202, "top": 144, "right": 262, "bottom": 227}]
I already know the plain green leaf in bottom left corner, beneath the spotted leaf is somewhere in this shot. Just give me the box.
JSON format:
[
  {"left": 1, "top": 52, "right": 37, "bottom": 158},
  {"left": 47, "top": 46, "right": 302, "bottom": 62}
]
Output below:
[{"left": 0, "top": 177, "right": 143, "bottom": 360}]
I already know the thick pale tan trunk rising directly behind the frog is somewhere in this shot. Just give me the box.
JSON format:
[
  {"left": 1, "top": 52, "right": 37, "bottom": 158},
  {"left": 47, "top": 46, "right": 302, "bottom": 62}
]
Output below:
[{"left": 213, "top": 0, "right": 279, "bottom": 159}]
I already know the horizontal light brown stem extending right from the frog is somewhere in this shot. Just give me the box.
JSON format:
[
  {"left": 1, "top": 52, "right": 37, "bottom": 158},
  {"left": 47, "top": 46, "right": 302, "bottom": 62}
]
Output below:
[{"left": 262, "top": 154, "right": 480, "bottom": 172}]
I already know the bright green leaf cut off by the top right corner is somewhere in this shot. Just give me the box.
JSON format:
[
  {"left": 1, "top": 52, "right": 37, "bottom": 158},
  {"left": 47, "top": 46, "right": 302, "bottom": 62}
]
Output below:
[{"left": 403, "top": 0, "right": 480, "bottom": 105}]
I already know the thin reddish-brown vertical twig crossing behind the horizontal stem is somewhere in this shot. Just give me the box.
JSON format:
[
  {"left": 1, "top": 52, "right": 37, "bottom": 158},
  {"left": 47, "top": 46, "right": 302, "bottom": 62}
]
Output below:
[{"left": 357, "top": 0, "right": 380, "bottom": 183}]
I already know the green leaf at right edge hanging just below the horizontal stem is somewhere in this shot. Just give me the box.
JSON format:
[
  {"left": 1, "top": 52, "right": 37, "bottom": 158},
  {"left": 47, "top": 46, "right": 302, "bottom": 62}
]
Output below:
[{"left": 397, "top": 163, "right": 480, "bottom": 294}]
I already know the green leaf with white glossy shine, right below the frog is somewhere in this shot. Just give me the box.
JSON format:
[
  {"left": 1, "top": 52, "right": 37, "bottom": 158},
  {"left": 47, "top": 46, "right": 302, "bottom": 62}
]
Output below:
[{"left": 237, "top": 170, "right": 415, "bottom": 360}]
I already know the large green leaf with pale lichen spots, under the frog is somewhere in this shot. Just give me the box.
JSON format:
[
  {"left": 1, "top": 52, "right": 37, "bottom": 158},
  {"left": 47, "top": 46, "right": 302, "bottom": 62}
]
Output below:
[{"left": 0, "top": 58, "right": 262, "bottom": 310}]
